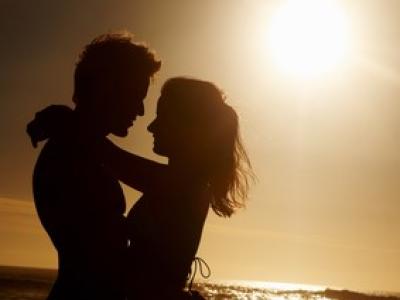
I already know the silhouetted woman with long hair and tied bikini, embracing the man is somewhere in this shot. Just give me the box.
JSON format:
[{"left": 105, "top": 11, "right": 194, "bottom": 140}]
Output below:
[{"left": 27, "top": 77, "right": 252, "bottom": 299}]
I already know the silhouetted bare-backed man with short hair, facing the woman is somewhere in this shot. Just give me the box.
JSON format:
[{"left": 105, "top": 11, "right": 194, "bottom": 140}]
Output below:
[{"left": 33, "top": 34, "right": 161, "bottom": 300}]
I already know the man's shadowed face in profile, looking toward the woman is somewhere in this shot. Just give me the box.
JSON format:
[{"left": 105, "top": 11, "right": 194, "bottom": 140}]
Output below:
[{"left": 107, "top": 76, "right": 150, "bottom": 137}]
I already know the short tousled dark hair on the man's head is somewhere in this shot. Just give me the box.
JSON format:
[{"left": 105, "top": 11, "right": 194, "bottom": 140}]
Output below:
[{"left": 73, "top": 32, "right": 161, "bottom": 103}]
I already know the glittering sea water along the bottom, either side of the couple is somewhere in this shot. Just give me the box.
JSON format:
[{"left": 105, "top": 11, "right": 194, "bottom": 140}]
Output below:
[{"left": 0, "top": 266, "right": 400, "bottom": 300}]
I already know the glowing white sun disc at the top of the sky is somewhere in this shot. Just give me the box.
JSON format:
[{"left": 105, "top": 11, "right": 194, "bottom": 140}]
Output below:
[{"left": 268, "top": 0, "right": 350, "bottom": 78}]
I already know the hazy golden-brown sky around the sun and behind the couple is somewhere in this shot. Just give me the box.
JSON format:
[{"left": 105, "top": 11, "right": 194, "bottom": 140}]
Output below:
[{"left": 0, "top": 0, "right": 400, "bottom": 291}]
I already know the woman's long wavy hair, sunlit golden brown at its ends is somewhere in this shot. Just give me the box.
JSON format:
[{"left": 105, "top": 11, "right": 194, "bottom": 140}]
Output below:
[{"left": 161, "top": 77, "right": 254, "bottom": 217}]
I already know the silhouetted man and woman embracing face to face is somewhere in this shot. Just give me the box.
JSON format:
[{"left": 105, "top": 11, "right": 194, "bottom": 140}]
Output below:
[{"left": 27, "top": 34, "right": 252, "bottom": 300}]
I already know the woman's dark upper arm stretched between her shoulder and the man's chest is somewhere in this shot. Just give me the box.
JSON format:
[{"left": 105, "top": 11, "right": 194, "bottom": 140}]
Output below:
[{"left": 96, "top": 139, "right": 167, "bottom": 192}]
